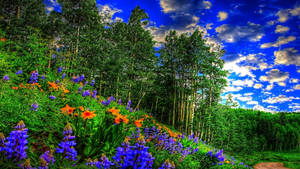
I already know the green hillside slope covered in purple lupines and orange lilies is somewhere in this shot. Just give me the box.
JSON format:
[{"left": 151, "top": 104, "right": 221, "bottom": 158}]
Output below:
[{"left": 0, "top": 69, "right": 247, "bottom": 169}]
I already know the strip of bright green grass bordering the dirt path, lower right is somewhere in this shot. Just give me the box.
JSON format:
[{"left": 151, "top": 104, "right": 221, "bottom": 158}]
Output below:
[{"left": 235, "top": 150, "right": 300, "bottom": 169}]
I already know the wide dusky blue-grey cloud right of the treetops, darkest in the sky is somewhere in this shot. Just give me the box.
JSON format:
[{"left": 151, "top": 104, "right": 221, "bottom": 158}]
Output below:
[{"left": 215, "top": 22, "right": 264, "bottom": 43}]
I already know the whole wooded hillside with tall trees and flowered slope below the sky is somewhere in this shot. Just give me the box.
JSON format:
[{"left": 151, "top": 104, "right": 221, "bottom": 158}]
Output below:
[{"left": 0, "top": 0, "right": 300, "bottom": 169}]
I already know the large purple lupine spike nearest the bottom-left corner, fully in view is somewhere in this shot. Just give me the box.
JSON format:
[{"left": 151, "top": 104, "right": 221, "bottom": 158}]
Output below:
[{"left": 4, "top": 120, "right": 28, "bottom": 161}]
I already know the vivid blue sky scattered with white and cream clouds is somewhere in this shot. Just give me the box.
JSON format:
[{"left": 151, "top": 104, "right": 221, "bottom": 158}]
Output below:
[{"left": 45, "top": 0, "right": 300, "bottom": 112}]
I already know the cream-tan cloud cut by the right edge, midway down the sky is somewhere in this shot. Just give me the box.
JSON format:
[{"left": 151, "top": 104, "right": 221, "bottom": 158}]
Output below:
[{"left": 274, "top": 48, "right": 300, "bottom": 66}]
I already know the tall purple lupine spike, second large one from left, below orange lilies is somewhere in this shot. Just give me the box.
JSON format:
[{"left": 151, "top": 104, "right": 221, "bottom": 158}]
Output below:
[{"left": 56, "top": 123, "right": 77, "bottom": 161}]
